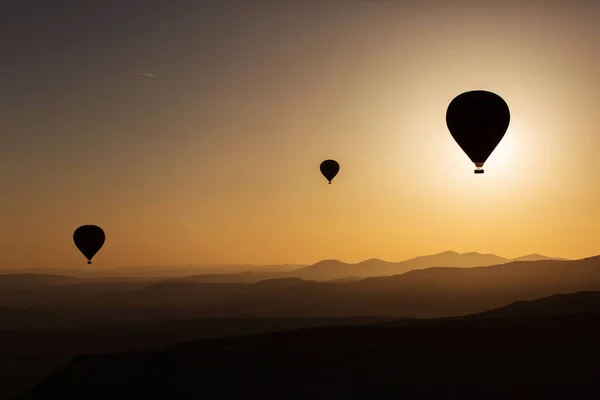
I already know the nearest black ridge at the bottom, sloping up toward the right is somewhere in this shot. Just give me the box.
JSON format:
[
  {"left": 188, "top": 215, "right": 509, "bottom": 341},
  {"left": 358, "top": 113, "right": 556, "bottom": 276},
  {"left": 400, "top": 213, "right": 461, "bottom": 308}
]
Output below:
[{"left": 16, "top": 293, "right": 600, "bottom": 400}]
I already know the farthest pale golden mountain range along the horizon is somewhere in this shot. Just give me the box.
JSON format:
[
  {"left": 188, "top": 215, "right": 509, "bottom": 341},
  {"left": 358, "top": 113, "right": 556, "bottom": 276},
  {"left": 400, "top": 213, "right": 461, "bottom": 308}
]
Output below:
[{"left": 0, "top": 251, "right": 564, "bottom": 283}]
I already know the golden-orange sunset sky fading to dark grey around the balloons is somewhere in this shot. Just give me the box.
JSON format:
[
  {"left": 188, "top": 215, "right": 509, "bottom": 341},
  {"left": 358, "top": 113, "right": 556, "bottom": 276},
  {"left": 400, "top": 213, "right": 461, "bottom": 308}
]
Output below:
[{"left": 0, "top": 0, "right": 600, "bottom": 267}]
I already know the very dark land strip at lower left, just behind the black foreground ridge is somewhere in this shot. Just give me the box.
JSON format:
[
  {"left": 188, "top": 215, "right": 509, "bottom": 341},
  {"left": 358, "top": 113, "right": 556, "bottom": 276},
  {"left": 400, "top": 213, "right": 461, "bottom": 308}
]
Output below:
[{"left": 0, "top": 318, "right": 392, "bottom": 399}]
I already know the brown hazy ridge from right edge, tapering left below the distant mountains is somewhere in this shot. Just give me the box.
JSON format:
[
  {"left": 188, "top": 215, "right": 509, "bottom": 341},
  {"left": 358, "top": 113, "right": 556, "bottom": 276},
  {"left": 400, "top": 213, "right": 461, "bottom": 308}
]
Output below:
[{"left": 210, "top": 257, "right": 600, "bottom": 318}]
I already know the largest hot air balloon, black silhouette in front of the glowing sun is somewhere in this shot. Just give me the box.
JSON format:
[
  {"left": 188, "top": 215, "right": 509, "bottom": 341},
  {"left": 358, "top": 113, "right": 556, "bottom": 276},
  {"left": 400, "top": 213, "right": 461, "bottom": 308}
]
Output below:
[{"left": 446, "top": 90, "right": 510, "bottom": 174}]
